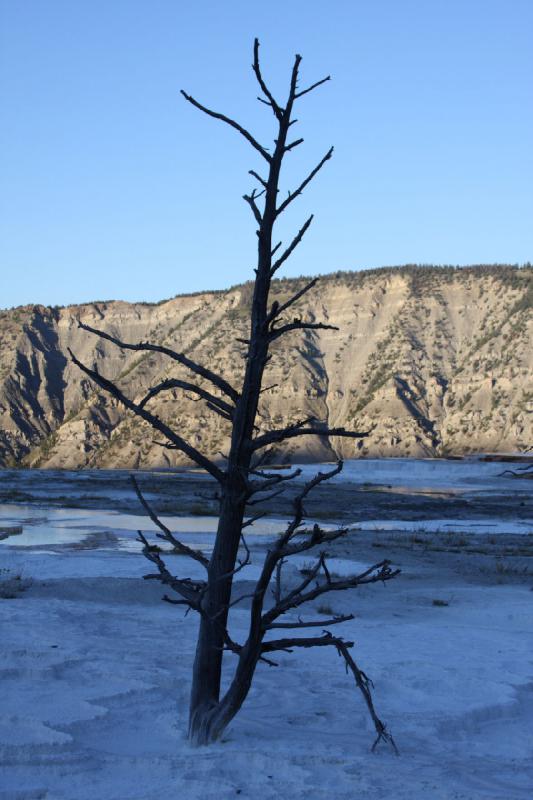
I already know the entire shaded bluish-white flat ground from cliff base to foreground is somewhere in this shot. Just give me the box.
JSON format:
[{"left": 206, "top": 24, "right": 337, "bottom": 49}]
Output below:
[{"left": 0, "top": 460, "right": 533, "bottom": 800}]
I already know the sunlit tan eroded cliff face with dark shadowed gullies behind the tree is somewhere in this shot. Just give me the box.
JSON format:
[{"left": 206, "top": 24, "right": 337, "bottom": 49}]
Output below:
[{"left": 0, "top": 266, "right": 533, "bottom": 468}]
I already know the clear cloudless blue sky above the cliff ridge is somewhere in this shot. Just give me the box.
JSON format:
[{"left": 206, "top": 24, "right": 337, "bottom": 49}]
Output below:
[{"left": 0, "top": 0, "right": 533, "bottom": 308}]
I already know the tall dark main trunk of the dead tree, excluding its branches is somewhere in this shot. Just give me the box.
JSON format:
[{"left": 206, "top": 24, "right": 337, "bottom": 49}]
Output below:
[{"left": 189, "top": 61, "right": 282, "bottom": 744}]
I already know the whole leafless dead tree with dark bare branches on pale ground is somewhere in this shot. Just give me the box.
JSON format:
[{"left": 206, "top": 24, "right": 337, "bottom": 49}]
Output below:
[{"left": 71, "top": 40, "right": 397, "bottom": 744}]
